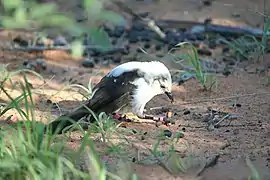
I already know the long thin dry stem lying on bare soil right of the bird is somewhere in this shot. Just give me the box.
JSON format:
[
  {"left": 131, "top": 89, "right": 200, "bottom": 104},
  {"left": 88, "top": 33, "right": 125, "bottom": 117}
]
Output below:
[{"left": 150, "top": 92, "right": 270, "bottom": 110}]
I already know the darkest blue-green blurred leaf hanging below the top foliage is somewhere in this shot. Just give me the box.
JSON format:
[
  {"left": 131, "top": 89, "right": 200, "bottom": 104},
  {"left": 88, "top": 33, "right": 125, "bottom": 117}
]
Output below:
[{"left": 90, "top": 28, "right": 112, "bottom": 51}]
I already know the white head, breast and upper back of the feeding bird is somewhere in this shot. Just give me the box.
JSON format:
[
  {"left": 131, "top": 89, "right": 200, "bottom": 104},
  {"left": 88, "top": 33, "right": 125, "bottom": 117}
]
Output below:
[{"left": 107, "top": 61, "right": 173, "bottom": 115}]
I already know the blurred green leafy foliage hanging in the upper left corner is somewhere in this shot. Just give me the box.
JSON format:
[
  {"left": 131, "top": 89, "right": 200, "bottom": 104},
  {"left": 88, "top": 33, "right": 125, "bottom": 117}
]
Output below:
[{"left": 0, "top": 0, "right": 125, "bottom": 57}]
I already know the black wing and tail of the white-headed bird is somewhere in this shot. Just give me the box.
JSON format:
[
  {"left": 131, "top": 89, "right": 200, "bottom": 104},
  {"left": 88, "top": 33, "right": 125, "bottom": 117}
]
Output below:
[{"left": 48, "top": 69, "right": 143, "bottom": 133}]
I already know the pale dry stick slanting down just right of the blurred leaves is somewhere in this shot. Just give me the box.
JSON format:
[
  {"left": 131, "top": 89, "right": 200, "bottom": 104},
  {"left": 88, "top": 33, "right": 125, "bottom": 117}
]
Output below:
[{"left": 114, "top": 1, "right": 166, "bottom": 39}]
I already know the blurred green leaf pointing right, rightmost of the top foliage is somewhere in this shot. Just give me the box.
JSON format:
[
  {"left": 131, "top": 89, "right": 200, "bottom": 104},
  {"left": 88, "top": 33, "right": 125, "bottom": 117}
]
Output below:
[{"left": 99, "top": 11, "right": 126, "bottom": 25}]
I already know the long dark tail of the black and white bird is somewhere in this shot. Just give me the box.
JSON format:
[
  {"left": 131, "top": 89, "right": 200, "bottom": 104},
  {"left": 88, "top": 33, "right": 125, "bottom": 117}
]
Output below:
[{"left": 45, "top": 106, "right": 91, "bottom": 134}]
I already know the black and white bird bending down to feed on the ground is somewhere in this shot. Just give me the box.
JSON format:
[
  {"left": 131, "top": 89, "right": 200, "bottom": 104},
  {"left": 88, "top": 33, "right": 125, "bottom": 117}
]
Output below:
[{"left": 45, "top": 61, "right": 173, "bottom": 132}]
